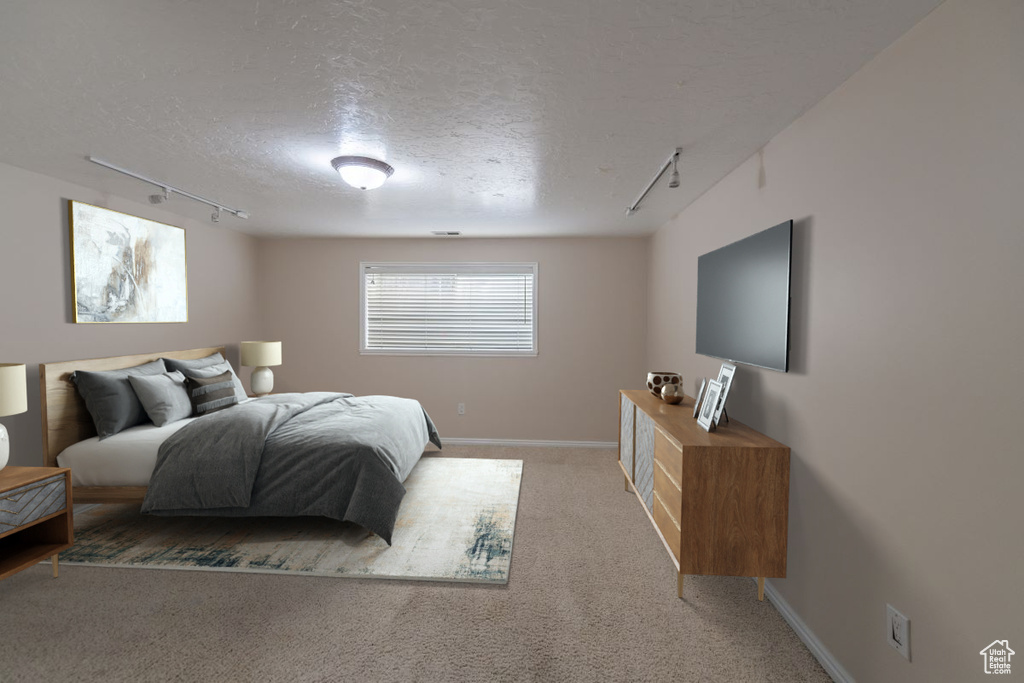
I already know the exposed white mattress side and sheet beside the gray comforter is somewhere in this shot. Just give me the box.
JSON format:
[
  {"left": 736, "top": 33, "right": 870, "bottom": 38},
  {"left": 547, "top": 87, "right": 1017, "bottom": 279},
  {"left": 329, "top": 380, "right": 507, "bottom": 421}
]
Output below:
[{"left": 57, "top": 418, "right": 199, "bottom": 486}]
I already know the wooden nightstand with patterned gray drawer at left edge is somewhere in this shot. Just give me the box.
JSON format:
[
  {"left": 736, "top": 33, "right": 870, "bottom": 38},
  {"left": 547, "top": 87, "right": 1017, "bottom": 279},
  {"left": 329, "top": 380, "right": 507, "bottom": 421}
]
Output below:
[{"left": 0, "top": 467, "right": 75, "bottom": 579}]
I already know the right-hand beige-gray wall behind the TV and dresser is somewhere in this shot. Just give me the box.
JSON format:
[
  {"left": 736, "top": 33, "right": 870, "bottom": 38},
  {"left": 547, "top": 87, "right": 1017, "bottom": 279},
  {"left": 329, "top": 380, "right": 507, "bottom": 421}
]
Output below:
[{"left": 647, "top": 0, "right": 1024, "bottom": 683}]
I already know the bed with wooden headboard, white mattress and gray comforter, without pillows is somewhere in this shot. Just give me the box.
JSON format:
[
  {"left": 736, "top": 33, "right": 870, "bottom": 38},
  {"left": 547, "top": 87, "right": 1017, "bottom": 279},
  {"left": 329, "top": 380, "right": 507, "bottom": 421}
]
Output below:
[{"left": 40, "top": 347, "right": 440, "bottom": 543}]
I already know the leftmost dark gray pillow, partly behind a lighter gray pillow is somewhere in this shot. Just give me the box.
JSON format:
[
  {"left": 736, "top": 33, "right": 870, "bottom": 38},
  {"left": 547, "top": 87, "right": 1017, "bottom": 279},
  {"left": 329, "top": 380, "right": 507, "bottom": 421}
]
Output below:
[{"left": 71, "top": 360, "right": 167, "bottom": 439}]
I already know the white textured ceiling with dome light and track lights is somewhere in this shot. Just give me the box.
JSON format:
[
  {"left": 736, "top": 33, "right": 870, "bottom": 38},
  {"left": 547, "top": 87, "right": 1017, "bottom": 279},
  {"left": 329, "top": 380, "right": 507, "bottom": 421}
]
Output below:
[{"left": 0, "top": 0, "right": 939, "bottom": 237}]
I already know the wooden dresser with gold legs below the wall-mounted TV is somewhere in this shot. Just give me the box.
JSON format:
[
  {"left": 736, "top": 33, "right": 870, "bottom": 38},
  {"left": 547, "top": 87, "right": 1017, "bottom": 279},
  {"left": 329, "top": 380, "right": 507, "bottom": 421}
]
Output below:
[{"left": 618, "top": 389, "right": 790, "bottom": 600}]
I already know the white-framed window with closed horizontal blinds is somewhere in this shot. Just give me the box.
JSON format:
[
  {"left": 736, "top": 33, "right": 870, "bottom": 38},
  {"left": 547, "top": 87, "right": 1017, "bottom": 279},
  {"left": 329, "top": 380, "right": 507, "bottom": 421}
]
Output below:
[{"left": 359, "top": 263, "right": 537, "bottom": 355}]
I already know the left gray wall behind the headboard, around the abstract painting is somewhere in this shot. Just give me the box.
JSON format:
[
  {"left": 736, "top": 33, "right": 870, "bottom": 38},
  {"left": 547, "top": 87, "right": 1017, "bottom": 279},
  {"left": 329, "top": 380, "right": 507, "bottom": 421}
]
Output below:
[{"left": 0, "top": 164, "right": 259, "bottom": 465}]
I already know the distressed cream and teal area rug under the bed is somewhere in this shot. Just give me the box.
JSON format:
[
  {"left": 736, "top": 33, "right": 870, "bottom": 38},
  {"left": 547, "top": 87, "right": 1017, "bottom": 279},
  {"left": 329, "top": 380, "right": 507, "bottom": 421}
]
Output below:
[{"left": 59, "top": 457, "right": 522, "bottom": 584}]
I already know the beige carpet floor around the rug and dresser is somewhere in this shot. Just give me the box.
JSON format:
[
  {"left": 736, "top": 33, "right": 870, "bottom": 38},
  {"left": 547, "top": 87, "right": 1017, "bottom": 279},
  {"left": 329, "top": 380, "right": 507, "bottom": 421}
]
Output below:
[{"left": 0, "top": 446, "right": 829, "bottom": 683}]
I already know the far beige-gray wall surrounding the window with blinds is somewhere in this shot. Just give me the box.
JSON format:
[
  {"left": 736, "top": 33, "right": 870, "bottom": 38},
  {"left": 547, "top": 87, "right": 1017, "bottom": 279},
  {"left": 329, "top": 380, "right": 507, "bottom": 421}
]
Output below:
[{"left": 253, "top": 239, "right": 647, "bottom": 441}]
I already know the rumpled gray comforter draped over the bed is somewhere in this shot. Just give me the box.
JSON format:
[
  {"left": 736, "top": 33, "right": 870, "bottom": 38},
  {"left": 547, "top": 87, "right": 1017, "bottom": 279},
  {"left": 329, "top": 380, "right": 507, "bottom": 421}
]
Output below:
[{"left": 142, "top": 393, "right": 440, "bottom": 545}]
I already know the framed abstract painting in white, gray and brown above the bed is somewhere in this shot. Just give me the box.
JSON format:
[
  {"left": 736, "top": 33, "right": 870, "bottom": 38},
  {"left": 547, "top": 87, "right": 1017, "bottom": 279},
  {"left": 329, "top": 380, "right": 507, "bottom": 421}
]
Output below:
[{"left": 68, "top": 200, "right": 188, "bottom": 323}]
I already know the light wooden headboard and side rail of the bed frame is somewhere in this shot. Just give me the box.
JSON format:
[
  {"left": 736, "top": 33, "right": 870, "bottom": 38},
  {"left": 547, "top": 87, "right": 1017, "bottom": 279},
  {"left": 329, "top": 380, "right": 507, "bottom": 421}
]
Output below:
[{"left": 39, "top": 346, "right": 226, "bottom": 503}]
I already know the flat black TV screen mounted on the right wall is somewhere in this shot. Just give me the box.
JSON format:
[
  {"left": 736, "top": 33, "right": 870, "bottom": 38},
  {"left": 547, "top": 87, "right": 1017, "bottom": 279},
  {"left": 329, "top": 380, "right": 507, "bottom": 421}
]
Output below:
[{"left": 696, "top": 220, "right": 793, "bottom": 373}]
